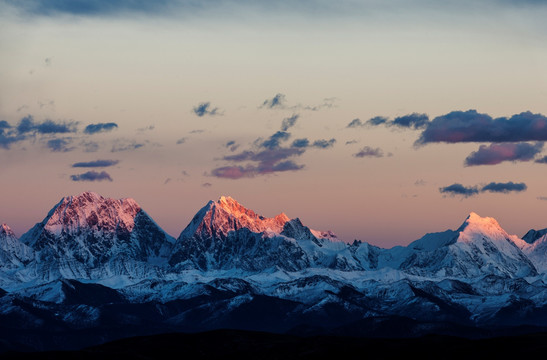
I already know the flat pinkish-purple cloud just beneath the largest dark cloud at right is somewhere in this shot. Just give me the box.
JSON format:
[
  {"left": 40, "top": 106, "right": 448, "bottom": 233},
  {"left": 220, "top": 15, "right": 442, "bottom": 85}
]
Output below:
[{"left": 465, "top": 142, "right": 543, "bottom": 166}]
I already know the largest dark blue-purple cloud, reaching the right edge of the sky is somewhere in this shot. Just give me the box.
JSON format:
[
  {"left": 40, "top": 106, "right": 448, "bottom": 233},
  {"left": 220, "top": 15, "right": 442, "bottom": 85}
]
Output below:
[{"left": 416, "top": 110, "right": 547, "bottom": 145}]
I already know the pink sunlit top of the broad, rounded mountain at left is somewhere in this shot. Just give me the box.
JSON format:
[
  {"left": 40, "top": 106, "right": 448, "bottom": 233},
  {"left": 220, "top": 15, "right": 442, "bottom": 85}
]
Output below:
[{"left": 45, "top": 191, "right": 141, "bottom": 234}]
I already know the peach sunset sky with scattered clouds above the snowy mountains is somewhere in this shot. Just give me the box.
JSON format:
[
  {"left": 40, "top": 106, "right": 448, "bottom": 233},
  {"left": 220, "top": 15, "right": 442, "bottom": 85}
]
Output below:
[{"left": 0, "top": 0, "right": 547, "bottom": 248}]
